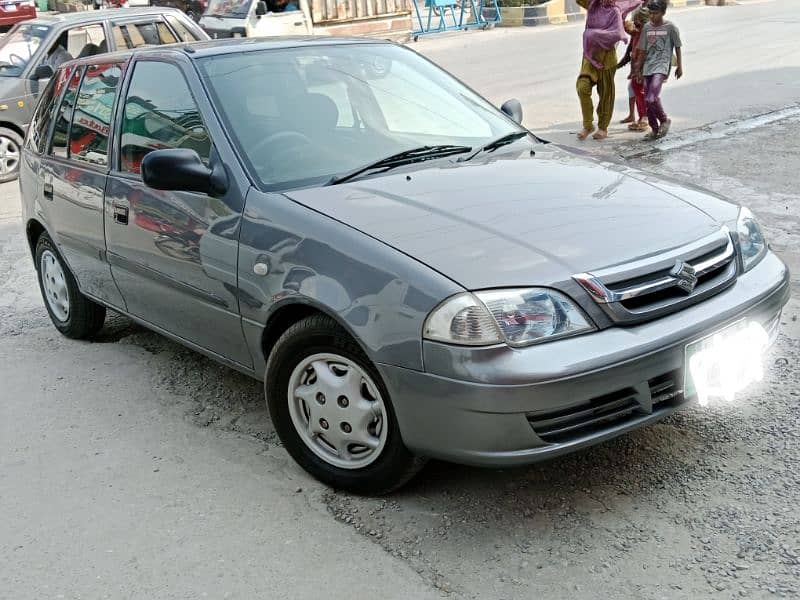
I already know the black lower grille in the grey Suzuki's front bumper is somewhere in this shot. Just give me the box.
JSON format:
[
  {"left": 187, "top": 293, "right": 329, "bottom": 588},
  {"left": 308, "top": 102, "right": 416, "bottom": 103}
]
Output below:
[{"left": 527, "top": 371, "right": 684, "bottom": 444}]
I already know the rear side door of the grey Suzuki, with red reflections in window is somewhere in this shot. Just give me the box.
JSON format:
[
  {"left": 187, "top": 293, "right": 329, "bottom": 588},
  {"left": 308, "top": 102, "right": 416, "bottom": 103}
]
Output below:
[{"left": 39, "top": 63, "right": 125, "bottom": 309}]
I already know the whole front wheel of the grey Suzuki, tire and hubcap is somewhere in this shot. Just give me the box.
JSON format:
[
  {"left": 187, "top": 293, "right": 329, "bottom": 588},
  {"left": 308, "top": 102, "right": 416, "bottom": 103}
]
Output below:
[{"left": 264, "top": 315, "right": 425, "bottom": 496}]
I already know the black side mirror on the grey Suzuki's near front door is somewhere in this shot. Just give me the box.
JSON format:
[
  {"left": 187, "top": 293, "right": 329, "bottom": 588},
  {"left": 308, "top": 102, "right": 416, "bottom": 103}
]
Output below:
[{"left": 142, "top": 148, "right": 228, "bottom": 197}]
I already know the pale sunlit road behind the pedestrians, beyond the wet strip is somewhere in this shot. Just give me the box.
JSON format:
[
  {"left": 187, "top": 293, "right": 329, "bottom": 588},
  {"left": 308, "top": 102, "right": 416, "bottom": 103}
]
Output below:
[{"left": 411, "top": 0, "right": 800, "bottom": 139}]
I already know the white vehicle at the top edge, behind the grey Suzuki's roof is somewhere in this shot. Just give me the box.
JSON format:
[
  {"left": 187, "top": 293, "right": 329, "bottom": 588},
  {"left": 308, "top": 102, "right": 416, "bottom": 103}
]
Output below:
[{"left": 200, "top": 0, "right": 312, "bottom": 39}]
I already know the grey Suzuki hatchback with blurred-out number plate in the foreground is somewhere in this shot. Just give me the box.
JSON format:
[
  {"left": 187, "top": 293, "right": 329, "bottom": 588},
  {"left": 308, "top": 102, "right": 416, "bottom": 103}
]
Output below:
[{"left": 20, "top": 39, "right": 789, "bottom": 494}]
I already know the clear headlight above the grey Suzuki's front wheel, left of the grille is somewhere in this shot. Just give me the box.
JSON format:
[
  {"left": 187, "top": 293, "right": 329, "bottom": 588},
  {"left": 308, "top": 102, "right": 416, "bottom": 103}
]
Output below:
[{"left": 424, "top": 288, "right": 594, "bottom": 347}]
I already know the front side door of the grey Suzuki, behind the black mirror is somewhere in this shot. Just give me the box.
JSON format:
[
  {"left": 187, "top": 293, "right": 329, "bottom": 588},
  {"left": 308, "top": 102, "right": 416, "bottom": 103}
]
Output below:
[{"left": 105, "top": 60, "right": 252, "bottom": 367}]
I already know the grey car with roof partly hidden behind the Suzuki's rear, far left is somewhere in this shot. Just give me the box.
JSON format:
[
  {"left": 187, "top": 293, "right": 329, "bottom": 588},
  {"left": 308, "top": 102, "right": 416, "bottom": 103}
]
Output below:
[{"left": 0, "top": 7, "right": 208, "bottom": 182}]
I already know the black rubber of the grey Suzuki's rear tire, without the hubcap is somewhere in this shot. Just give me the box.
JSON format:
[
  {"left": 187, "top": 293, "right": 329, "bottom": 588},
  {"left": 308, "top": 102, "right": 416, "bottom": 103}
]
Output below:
[{"left": 35, "top": 233, "right": 106, "bottom": 340}]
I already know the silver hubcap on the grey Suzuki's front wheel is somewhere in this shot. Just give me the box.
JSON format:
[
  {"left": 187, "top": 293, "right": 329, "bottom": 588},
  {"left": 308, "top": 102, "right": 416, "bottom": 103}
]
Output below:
[{"left": 288, "top": 354, "right": 388, "bottom": 469}]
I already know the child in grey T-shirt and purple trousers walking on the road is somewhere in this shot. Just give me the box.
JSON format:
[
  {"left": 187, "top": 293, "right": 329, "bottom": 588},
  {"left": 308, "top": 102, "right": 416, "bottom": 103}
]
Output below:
[{"left": 635, "top": 0, "right": 683, "bottom": 140}]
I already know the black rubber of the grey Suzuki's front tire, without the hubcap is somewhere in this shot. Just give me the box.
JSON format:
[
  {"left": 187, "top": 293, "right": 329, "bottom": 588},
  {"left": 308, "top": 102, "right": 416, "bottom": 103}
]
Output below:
[{"left": 264, "top": 315, "right": 426, "bottom": 496}]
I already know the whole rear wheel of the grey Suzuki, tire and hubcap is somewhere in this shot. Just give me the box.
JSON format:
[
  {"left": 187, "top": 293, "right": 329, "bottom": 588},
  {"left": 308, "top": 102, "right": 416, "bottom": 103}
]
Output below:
[{"left": 35, "top": 233, "right": 106, "bottom": 340}]
